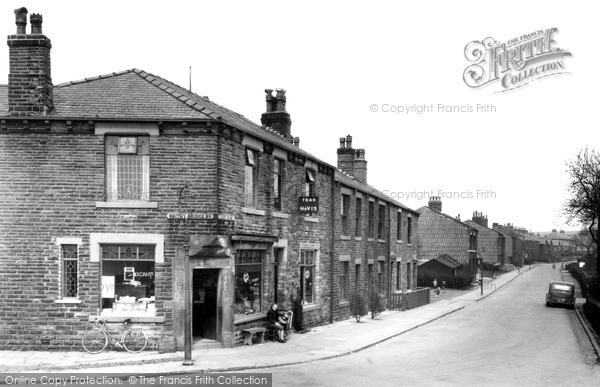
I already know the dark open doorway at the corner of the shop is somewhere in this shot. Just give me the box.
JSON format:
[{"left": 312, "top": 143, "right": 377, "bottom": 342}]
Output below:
[{"left": 192, "top": 269, "right": 219, "bottom": 340}]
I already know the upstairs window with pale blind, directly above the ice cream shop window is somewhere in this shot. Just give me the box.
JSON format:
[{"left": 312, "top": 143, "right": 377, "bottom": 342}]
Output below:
[{"left": 105, "top": 135, "right": 150, "bottom": 201}]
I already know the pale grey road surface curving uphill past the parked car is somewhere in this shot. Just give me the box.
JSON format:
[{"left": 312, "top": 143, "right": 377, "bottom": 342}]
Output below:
[{"left": 253, "top": 265, "right": 600, "bottom": 386}]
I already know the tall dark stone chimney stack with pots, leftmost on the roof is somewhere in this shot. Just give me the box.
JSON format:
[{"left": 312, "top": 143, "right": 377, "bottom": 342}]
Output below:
[{"left": 7, "top": 7, "right": 54, "bottom": 116}]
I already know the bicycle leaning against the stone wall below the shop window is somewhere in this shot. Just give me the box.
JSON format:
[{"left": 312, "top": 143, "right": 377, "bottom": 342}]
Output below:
[{"left": 81, "top": 319, "right": 148, "bottom": 353}]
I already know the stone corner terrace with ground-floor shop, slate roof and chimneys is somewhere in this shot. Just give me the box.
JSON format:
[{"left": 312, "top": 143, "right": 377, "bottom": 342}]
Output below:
[{"left": 0, "top": 8, "right": 419, "bottom": 350}]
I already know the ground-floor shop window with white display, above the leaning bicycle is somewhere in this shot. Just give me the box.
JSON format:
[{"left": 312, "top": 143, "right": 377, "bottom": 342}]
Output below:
[{"left": 100, "top": 245, "right": 156, "bottom": 316}]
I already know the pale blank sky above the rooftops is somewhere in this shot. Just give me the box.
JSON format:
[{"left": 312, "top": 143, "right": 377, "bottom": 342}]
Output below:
[{"left": 0, "top": 0, "right": 600, "bottom": 231}]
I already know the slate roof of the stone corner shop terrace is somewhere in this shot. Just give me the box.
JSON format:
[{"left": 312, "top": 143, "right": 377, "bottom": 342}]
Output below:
[{"left": 0, "top": 69, "right": 418, "bottom": 215}]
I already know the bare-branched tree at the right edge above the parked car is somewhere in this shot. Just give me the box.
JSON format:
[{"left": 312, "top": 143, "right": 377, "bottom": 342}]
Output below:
[{"left": 564, "top": 148, "right": 600, "bottom": 278}]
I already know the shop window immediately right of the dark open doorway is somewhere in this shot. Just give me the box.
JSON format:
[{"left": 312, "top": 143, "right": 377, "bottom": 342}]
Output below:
[{"left": 235, "top": 250, "right": 264, "bottom": 315}]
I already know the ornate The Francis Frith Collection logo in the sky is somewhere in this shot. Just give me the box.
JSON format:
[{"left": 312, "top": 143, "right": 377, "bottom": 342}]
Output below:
[{"left": 463, "top": 28, "right": 571, "bottom": 92}]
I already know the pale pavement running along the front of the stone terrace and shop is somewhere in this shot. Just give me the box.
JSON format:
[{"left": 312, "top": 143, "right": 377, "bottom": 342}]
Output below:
[{"left": 0, "top": 265, "right": 535, "bottom": 375}]
